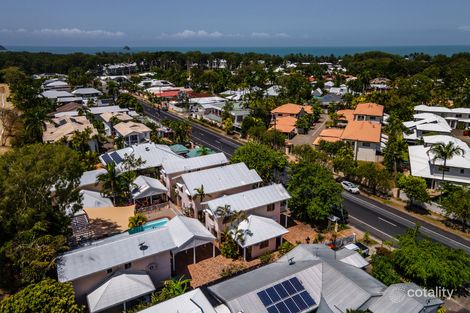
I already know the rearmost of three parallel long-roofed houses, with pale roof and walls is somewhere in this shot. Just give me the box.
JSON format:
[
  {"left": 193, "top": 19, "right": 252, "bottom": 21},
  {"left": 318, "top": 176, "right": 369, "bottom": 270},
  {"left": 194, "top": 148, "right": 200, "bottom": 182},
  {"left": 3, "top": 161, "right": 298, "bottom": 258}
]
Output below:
[{"left": 160, "top": 151, "right": 229, "bottom": 200}]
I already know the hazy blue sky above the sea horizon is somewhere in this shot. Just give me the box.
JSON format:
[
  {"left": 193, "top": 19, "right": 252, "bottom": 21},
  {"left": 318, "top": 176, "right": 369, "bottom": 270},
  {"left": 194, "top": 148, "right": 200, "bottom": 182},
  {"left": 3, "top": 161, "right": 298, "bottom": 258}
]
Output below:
[{"left": 0, "top": 0, "right": 470, "bottom": 46}]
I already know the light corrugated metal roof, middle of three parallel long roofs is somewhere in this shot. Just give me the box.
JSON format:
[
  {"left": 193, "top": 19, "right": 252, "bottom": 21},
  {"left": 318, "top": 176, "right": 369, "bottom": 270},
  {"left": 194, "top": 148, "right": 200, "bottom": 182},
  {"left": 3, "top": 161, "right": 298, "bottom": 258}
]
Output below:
[{"left": 181, "top": 163, "right": 262, "bottom": 196}]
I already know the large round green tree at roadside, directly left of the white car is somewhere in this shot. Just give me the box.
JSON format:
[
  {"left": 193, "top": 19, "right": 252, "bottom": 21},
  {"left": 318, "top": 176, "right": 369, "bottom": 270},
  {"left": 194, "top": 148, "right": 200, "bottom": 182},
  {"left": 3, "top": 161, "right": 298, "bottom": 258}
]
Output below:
[{"left": 288, "top": 162, "right": 342, "bottom": 225}]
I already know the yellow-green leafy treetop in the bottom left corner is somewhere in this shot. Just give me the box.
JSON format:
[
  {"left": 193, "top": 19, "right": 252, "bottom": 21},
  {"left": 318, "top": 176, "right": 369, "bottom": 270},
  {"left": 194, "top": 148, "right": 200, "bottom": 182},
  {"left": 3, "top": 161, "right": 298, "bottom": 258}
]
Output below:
[{"left": 0, "top": 278, "right": 85, "bottom": 313}]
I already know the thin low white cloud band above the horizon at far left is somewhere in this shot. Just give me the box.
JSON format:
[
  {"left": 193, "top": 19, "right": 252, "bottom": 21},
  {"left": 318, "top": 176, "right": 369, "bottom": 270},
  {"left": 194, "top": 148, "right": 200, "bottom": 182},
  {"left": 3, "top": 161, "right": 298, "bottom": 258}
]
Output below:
[{"left": 0, "top": 28, "right": 125, "bottom": 38}]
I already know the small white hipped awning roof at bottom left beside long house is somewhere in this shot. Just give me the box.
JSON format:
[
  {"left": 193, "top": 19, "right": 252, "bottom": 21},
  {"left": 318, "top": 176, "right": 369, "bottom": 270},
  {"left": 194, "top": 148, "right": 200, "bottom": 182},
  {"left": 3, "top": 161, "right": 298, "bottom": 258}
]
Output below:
[{"left": 87, "top": 272, "right": 155, "bottom": 313}]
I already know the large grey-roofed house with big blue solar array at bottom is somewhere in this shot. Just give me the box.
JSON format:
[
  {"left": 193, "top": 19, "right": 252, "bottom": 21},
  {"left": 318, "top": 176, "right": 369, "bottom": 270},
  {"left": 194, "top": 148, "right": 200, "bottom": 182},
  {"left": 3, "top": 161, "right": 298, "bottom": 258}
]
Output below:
[{"left": 207, "top": 244, "right": 443, "bottom": 313}]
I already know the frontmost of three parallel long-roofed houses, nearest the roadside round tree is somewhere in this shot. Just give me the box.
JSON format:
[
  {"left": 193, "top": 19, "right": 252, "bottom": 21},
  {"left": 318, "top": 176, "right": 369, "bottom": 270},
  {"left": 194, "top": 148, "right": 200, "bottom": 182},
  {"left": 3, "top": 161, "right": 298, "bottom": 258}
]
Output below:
[{"left": 201, "top": 184, "right": 290, "bottom": 239}]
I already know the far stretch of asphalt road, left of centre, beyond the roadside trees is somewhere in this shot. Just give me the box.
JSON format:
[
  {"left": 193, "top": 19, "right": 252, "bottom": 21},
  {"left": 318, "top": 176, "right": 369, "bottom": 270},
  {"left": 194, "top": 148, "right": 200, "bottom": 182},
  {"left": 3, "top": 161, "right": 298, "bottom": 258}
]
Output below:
[{"left": 140, "top": 100, "right": 241, "bottom": 157}]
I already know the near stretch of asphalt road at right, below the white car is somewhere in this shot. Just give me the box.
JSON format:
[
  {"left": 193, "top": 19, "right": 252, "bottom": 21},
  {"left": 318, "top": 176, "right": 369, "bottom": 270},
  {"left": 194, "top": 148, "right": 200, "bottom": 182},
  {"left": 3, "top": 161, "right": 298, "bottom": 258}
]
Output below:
[{"left": 342, "top": 192, "right": 470, "bottom": 254}]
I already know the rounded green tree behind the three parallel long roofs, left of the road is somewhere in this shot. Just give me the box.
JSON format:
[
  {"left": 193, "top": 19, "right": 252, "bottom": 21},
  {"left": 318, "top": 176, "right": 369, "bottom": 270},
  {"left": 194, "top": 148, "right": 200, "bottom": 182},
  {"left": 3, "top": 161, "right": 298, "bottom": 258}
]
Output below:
[{"left": 231, "top": 142, "right": 287, "bottom": 182}]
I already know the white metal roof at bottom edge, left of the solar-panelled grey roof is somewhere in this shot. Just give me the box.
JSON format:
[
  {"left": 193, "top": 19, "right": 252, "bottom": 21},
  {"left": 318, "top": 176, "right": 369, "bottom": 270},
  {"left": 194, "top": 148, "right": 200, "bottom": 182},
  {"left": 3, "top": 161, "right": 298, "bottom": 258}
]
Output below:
[{"left": 139, "top": 288, "right": 217, "bottom": 313}]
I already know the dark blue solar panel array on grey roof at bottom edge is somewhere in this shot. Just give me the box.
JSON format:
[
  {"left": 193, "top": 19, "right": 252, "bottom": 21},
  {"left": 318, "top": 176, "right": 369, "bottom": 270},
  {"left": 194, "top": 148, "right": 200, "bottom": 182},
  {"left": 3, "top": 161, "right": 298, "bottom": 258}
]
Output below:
[{"left": 258, "top": 277, "right": 316, "bottom": 313}]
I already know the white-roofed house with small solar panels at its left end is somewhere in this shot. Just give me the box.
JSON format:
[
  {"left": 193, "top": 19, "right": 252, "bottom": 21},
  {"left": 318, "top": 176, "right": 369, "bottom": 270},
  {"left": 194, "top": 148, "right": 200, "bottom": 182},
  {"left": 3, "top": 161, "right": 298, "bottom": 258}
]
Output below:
[{"left": 100, "top": 143, "right": 184, "bottom": 173}]
